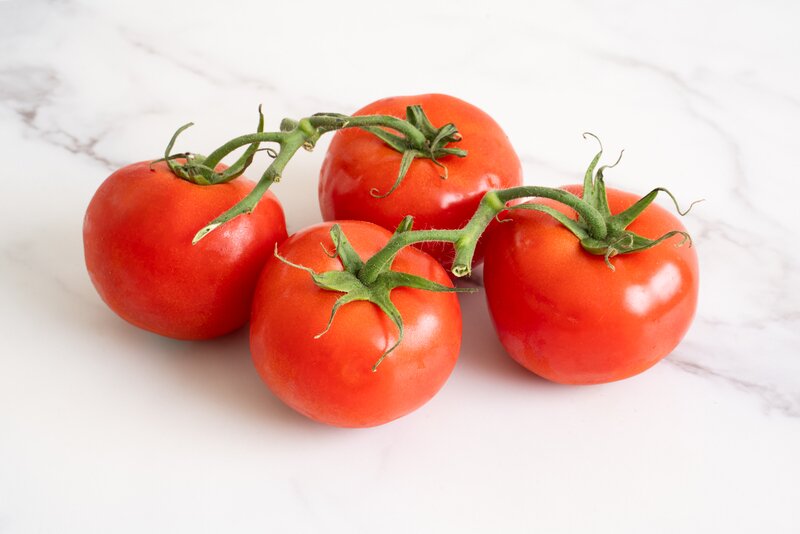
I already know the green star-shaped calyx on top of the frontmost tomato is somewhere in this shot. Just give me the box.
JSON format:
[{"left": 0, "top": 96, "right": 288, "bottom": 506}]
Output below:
[{"left": 275, "top": 222, "right": 475, "bottom": 372}]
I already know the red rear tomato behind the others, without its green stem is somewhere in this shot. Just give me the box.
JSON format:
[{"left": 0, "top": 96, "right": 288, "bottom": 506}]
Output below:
[{"left": 319, "top": 94, "right": 522, "bottom": 267}]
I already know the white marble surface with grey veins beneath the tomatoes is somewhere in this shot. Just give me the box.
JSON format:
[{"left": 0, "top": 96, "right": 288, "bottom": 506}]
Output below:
[{"left": 0, "top": 0, "right": 800, "bottom": 534}]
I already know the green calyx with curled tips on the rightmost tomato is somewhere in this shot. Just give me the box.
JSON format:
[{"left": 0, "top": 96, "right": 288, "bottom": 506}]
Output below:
[{"left": 509, "top": 132, "right": 700, "bottom": 270}]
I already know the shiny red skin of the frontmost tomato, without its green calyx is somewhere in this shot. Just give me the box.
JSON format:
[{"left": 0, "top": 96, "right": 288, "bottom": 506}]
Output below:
[{"left": 250, "top": 221, "right": 461, "bottom": 427}]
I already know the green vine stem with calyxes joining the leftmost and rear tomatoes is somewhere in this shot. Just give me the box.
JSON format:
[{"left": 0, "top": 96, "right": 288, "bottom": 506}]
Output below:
[{"left": 158, "top": 106, "right": 467, "bottom": 244}]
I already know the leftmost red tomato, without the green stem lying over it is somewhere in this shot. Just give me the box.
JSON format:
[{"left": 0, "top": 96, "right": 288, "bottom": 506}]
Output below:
[{"left": 83, "top": 162, "right": 286, "bottom": 339}]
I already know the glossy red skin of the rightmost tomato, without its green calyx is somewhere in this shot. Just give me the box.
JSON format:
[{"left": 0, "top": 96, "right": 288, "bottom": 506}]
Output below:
[{"left": 484, "top": 186, "right": 699, "bottom": 384}]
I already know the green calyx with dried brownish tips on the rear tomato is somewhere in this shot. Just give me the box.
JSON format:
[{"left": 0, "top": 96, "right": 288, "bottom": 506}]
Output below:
[{"left": 362, "top": 106, "right": 467, "bottom": 198}]
